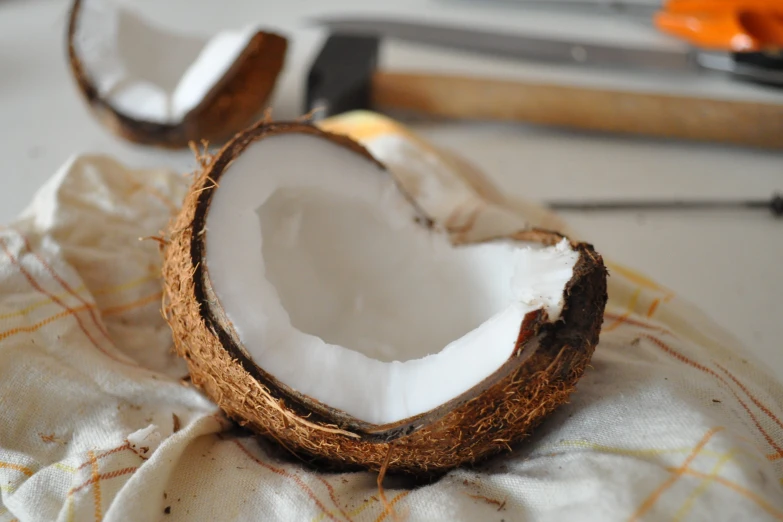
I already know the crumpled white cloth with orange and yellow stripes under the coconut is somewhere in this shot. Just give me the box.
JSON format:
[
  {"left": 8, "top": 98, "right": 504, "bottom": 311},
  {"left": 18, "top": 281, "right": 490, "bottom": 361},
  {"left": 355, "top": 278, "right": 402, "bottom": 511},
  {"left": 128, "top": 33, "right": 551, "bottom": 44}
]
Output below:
[{"left": 0, "top": 115, "right": 783, "bottom": 522}]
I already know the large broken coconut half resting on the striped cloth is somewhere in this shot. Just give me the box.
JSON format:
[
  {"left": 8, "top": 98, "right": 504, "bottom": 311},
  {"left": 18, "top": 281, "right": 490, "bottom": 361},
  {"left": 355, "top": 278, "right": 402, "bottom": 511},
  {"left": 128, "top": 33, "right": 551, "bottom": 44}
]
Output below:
[{"left": 163, "top": 122, "right": 607, "bottom": 475}]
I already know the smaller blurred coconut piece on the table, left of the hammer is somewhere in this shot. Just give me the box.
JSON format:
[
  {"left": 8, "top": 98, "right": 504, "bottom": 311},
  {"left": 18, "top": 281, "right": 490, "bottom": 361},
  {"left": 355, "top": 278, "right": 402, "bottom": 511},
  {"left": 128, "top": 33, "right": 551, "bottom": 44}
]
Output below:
[{"left": 67, "top": 0, "right": 287, "bottom": 148}]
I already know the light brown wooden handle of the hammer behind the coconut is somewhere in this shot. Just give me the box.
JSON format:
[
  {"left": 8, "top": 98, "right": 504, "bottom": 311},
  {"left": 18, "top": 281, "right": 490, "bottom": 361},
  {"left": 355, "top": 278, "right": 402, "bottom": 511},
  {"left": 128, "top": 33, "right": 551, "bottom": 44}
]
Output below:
[{"left": 372, "top": 72, "right": 783, "bottom": 149}]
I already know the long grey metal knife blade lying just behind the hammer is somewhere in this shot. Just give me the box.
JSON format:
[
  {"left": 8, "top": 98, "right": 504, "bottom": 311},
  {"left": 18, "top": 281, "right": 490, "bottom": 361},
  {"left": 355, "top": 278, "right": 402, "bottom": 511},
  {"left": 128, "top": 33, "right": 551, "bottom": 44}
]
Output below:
[{"left": 316, "top": 17, "right": 701, "bottom": 73}]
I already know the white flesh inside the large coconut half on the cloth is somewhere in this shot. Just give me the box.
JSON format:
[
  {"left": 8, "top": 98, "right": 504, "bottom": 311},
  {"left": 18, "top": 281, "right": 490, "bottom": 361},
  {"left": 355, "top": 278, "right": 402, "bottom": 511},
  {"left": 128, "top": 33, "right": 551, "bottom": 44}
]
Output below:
[{"left": 204, "top": 133, "right": 579, "bottom": 424}]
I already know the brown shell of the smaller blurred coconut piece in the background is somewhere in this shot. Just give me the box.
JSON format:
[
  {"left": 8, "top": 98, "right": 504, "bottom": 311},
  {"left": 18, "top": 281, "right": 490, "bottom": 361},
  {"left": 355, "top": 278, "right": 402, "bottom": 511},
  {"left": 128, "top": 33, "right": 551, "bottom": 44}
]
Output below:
[{"left": 67, "top": 0, "right": 288, "bottom": 148}]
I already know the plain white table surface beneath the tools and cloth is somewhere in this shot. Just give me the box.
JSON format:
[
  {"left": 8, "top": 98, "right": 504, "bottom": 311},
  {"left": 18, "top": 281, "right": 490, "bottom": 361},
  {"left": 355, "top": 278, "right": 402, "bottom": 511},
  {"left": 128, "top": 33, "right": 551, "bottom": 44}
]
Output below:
[{"left": 0, "top": 0, "right": 783, "bottom": 376}]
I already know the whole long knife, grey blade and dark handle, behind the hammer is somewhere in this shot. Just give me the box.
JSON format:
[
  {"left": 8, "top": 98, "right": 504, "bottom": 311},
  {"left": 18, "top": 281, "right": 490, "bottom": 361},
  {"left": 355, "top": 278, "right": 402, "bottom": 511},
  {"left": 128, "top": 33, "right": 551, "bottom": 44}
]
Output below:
[{"left": 317, "top": 16, "right": 783, "bottom": 87}]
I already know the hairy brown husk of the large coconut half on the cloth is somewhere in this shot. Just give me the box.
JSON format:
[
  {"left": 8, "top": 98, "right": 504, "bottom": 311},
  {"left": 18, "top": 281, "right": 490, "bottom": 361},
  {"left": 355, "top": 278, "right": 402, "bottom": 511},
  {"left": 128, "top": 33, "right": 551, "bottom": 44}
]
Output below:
[{"left": 163, "top": 122, "right": 607, "bottom": 476}]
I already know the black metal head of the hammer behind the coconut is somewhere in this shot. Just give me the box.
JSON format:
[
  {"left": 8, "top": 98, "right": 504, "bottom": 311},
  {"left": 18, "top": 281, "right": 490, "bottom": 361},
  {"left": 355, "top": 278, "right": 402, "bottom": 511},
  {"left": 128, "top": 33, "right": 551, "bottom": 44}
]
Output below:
[{"left": 305, "top": 34, "right": 379, "bottom": 119}]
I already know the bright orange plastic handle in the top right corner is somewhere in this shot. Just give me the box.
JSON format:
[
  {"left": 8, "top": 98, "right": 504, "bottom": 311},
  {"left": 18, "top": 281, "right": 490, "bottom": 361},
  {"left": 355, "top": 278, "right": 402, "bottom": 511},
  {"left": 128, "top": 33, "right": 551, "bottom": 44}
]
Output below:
[{"left": 654, "top": 0, "right": 783, "bottom": 52}]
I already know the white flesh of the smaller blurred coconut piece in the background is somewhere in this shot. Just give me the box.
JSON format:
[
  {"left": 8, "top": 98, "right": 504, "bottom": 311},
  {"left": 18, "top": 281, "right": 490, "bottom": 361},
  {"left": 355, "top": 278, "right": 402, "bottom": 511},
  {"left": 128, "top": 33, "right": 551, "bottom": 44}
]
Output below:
[{"left": 73, "top": 0, "right": 256, "bottom": 124}]
